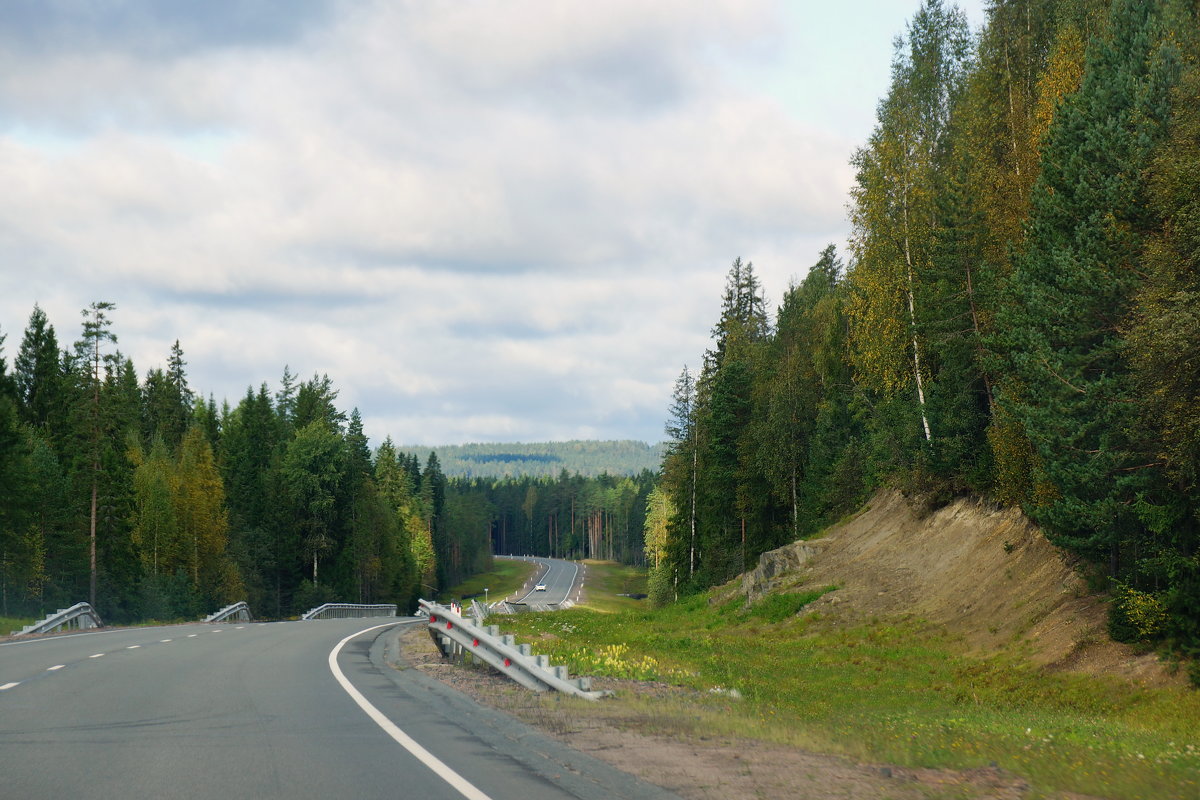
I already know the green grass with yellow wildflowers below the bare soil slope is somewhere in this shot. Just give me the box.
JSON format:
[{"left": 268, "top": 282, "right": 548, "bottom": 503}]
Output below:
[{"left": 494, "top": 587, "right": 1200, "bottom": 800}]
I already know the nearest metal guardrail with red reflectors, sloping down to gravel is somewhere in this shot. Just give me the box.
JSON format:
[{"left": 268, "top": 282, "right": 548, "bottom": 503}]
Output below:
[{"left": 420, "top": 600, "right": 608, "bottom": 700}]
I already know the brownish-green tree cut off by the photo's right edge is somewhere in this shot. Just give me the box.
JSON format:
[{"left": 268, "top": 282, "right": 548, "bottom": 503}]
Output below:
[{"left": 1124, "top": 50, "right": 1200, "bottom": 649}]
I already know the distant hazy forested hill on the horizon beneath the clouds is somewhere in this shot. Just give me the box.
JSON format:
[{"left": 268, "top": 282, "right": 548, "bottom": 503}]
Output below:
[{"left": 401, "top": 440, "right": 664, "bottom": 477}]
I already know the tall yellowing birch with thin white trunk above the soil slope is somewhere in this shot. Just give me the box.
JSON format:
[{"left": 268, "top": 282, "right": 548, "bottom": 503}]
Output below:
[{"left": 848, "top": 0, "right": 971, "bottom": 450}]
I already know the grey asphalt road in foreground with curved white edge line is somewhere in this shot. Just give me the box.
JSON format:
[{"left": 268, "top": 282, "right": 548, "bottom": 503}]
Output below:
[{"left": 0, "top": 618, "right": 671, "bottom": 800}]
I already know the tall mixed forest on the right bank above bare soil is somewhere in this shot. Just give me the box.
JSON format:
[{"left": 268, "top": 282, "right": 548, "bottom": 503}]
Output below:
[{"left": 646, "top": 0, "right": 1200, "bottom": 655}]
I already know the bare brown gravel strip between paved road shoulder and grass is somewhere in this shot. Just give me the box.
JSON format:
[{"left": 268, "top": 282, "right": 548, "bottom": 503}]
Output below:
[{"left": 396, "top": 625, "right": 1086, "bottom": 800}]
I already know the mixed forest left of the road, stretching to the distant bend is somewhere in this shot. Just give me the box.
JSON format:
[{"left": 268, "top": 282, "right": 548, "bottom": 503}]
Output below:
[{"left": 0, "top": 302, "right": 655, "bottom": 622}]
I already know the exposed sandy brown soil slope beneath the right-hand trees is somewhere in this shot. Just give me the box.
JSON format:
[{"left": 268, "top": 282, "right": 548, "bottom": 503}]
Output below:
[{"left": 731, "top": 492, "right": 1183, "bottom": 685}]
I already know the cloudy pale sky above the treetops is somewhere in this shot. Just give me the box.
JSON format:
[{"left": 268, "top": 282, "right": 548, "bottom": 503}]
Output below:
[{"left": 0, "top": 0, "right": 984, "bottom": 445}]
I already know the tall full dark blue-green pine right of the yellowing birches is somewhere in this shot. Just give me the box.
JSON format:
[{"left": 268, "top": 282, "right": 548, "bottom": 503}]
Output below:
[{"left": 996, "top": 0, "right": 1178, "bottom": 575}]
